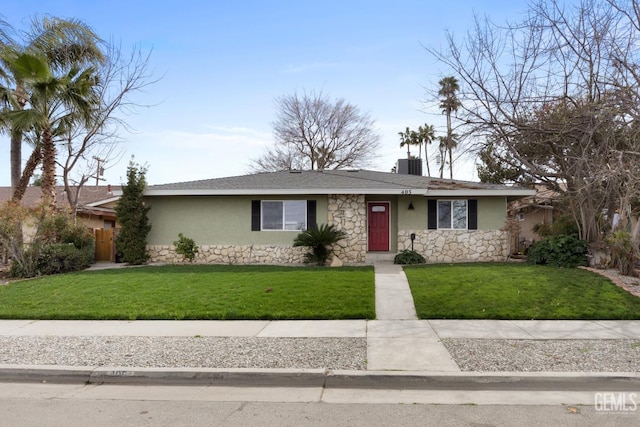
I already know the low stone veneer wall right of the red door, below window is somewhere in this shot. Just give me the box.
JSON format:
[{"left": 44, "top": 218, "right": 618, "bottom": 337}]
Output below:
[{"left": 398, "top": 230, "right": 509, "bottom": 263}]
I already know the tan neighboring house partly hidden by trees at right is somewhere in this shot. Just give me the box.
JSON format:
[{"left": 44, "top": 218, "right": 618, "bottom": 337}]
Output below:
[{"left": 509, "top": 185, "right": 560, "bottom": 252}]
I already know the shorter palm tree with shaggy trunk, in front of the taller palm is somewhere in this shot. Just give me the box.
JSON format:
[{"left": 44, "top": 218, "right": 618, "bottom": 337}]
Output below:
[{"left": 8, "top": 53, "right": 97, "bottom": 209}]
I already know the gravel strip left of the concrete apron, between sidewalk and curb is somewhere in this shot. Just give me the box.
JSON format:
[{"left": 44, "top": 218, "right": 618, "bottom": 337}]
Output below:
[{"left": 0, "top": 336, "right": 367, "bottom": 370}]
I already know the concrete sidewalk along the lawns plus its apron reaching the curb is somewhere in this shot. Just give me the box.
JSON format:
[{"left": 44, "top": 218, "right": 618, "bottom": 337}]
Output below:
[{"left": 0, "top": 320, "right": 640, "bottom": 373}]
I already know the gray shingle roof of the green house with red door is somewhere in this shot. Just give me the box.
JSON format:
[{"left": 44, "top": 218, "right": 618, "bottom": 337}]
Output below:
[{"left": 145, "top": 170, "right": 536, "bottom": 196}]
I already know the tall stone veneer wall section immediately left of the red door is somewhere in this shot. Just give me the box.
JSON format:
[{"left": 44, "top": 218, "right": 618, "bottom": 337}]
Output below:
[{"left": 327, "top": 194, "right": 367, "bottom": 264}]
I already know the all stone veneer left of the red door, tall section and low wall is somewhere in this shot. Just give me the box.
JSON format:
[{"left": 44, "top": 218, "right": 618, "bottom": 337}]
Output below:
[{"left": 147, "top": 194, "right": 367, "bottom": 264}]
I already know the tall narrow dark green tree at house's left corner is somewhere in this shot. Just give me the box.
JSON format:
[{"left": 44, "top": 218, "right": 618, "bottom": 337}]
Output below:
[{"left": 116, "top": 159, "right": 151, "bottom": 265}]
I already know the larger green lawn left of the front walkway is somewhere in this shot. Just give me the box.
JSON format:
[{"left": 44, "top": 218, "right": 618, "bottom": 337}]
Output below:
[{"left": 0, "top": 265, "right": 375, "bottom": 320}]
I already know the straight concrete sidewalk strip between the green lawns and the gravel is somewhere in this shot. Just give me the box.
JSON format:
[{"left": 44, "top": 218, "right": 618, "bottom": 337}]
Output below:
[{"left": 0, "top": 319, "right": 640, "bottom": 342}]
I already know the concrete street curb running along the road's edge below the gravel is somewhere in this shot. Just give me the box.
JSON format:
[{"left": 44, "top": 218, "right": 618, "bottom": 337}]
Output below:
[{"left": 0, "top": 365, "right": 640, "bottom": 391}]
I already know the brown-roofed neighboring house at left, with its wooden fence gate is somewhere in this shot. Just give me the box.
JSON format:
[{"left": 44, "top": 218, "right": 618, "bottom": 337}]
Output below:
[{"left": 0, "top": 185, "right": 121, "bottom": 261}]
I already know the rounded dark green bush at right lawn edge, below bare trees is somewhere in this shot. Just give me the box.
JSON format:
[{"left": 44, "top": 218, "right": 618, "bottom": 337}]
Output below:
[{"left": 527, "top": 234, "right": 588, "bottom": 267}]
